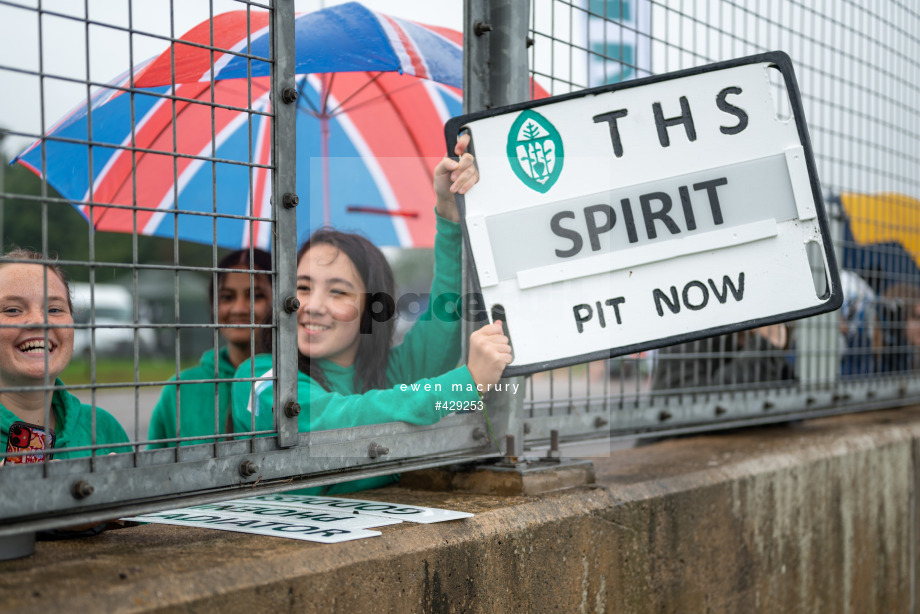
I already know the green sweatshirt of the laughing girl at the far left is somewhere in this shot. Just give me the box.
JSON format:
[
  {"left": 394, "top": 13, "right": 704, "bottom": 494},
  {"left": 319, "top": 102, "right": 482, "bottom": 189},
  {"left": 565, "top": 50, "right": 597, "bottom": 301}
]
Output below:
[{"left": 0, "top": 379, "right": 131, "bottom": 459}]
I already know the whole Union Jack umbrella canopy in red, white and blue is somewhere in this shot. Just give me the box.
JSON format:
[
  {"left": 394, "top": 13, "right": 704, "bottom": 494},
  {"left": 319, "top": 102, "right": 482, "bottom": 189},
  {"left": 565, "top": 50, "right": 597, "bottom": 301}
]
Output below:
[{"left": 15, "top": 3, "right": 462, "bottom": 247}]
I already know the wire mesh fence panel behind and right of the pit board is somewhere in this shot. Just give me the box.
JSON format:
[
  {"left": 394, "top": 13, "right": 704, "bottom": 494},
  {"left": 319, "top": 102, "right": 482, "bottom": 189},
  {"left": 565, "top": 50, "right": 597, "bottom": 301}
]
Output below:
[{"left": 525, "top": 0, "right": 920, "bottom": 452}]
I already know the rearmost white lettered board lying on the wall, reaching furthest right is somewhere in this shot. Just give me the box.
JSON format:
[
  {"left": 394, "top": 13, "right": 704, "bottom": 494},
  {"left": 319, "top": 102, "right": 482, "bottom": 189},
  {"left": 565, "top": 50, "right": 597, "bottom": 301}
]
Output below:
[{"left": 236, "top": 493, "right": 473, "bottom": 524}]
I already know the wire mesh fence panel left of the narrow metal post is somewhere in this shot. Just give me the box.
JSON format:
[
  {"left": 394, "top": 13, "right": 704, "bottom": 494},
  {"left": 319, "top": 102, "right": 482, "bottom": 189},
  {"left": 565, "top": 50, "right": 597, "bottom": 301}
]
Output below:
[{"left": 0, "top": 2, "right": 292, "bottom": 526}]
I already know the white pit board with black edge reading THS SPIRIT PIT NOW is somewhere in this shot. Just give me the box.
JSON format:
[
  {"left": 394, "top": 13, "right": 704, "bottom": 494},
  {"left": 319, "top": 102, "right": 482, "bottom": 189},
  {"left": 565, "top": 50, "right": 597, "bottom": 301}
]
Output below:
[{"left": 445, "top": 52, "right": 842, "bottom": 376}]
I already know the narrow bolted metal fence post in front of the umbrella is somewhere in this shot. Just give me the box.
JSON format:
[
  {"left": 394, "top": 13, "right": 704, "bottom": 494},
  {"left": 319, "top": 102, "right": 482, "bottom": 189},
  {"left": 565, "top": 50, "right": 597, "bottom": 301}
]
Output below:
[{"left": 272, "top": 0, "right": 299, "bottom": 447}]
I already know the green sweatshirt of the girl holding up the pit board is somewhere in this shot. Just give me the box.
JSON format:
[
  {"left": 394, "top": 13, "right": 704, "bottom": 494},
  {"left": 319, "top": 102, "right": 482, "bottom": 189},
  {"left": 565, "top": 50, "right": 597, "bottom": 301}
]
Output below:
[{"left": 233, "top": 217, "right": 479, "bottom": 495}]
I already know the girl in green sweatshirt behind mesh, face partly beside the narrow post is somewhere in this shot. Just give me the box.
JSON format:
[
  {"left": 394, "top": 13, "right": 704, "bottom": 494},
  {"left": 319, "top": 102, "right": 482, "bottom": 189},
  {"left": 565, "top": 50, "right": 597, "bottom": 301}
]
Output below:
[{"left": 147, "top": 248, "right": 272, "bottom": 449}]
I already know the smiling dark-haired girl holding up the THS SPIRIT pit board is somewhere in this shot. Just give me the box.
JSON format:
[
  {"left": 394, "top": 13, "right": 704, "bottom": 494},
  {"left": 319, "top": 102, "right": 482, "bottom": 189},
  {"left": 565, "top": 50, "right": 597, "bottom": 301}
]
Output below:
[{"left": 233, "top": 135, "right": 511, "bottom": 494}]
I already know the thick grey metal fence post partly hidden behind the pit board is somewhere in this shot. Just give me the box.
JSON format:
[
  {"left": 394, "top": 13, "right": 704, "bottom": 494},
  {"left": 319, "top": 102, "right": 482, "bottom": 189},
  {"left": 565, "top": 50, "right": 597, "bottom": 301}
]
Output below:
[{"left": 463, "top": 0, "right": 530, "bottom": 456}]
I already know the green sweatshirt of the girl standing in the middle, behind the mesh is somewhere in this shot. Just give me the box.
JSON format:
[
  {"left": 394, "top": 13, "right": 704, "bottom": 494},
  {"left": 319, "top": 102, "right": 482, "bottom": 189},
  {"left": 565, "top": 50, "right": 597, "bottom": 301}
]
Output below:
[{"left": 147, "top": 348, "right": 236, "bottom": 450}]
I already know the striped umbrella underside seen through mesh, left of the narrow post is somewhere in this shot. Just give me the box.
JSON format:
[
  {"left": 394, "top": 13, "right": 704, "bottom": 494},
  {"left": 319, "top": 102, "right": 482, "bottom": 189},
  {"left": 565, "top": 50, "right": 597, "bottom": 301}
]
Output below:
[{"left": 17, "top": 78, "right": 271, "bottom": 247}]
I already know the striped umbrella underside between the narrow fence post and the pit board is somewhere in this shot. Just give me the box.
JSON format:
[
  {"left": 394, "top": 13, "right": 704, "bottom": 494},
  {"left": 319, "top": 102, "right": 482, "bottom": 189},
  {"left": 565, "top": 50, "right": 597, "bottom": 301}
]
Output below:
[{"left": 297, "top": 73, "right": 462, "bottom": 247}]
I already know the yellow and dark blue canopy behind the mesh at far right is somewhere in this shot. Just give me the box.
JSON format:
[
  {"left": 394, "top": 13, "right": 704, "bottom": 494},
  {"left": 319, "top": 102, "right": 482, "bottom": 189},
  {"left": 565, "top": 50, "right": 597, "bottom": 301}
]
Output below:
[{"left": 840, "top": 193, "right": 920, "bottom": 295}]
